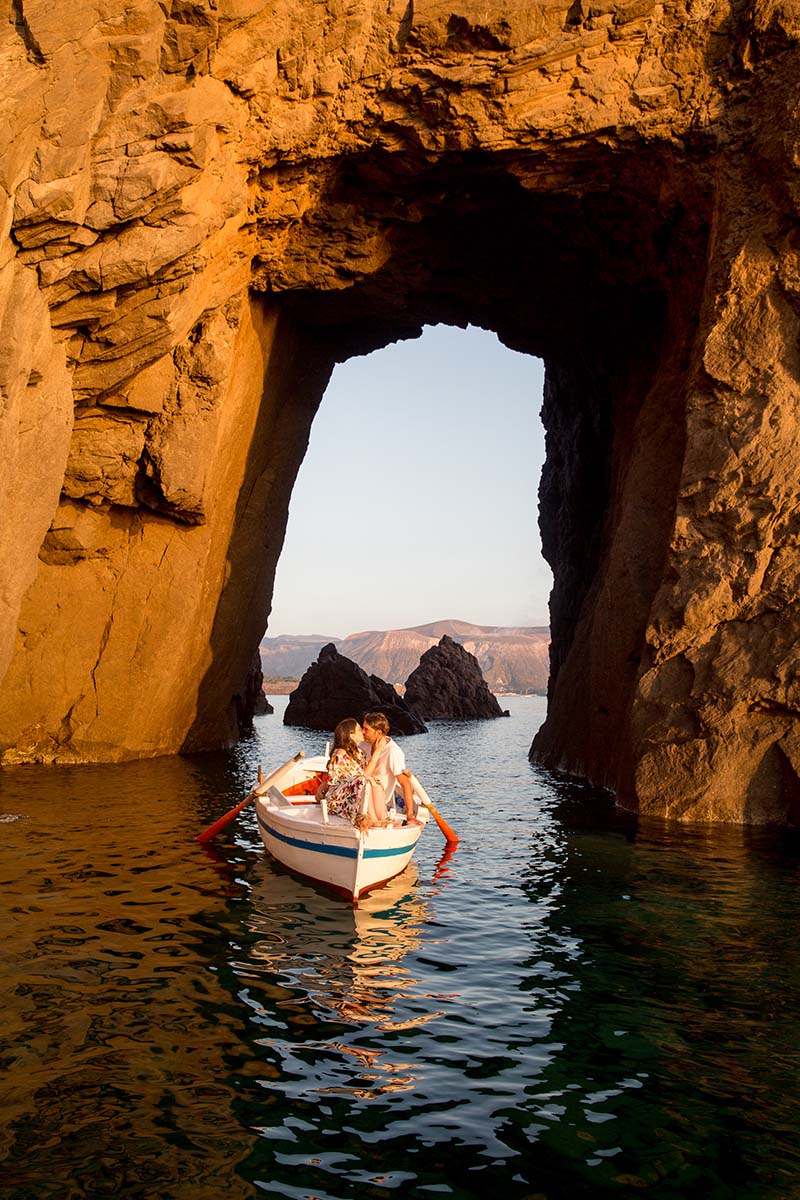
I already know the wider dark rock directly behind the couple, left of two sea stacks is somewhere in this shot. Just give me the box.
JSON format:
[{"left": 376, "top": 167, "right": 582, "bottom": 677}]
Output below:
[{"left": 283, "top": 642, "right": 427, "bottom": 733}]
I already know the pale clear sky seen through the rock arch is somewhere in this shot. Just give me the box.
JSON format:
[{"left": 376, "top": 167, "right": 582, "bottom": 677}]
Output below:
[{"left": 266, "top": 325, "right": 552, "bottom": 637}]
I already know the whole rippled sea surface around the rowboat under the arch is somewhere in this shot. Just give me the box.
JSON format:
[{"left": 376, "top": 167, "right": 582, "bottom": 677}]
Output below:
[{"left": 0, "top": 697, "right": 800, "bottom": 1200}]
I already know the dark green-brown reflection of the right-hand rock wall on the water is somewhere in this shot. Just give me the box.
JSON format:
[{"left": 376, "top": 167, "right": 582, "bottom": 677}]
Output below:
[{"left": 504, "top": 805, "right": 799, "bottom": 1198}]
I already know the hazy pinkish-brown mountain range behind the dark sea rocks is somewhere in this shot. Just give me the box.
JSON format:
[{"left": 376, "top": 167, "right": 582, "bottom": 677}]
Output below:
[{"left": 261, "top": 620, "right": 551, "bottom": 694}]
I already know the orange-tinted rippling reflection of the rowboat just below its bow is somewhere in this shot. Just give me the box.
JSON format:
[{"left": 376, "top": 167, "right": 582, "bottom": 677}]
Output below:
[{"left": 233, "top": 859, "right": 440, "bottom": 1099}]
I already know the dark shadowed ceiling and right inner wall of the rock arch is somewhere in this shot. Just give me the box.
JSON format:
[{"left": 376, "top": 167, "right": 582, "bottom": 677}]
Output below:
[{"left": 226, "top": 144, "right": 709, "bottom": 793}]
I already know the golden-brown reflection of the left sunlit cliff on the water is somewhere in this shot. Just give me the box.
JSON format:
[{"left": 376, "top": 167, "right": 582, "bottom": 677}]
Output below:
[{"left": 0, "top": 762, "right": 266, "bottom": 1200}]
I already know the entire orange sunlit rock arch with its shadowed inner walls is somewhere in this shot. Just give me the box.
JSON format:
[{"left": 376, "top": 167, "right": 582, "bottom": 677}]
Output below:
[{"left": 0, "top": 0, "right": 800, "bottom": 822}]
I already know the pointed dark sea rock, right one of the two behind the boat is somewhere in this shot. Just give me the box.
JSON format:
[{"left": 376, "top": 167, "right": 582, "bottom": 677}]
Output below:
[{"left": 405, "top": 634, "right": 509, "bottom": 721}]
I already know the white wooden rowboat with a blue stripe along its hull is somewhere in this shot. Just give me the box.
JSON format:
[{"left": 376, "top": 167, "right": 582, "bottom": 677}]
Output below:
[{"left": 253, "top": 755, "right": 428, "bottom": 902}]
